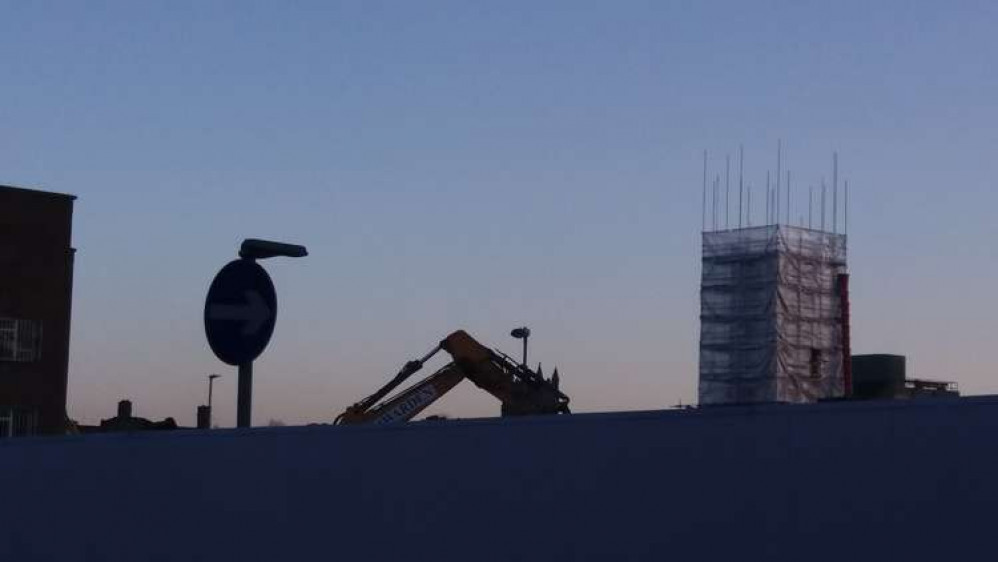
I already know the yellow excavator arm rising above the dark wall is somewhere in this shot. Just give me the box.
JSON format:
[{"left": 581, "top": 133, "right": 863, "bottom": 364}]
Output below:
[{"left": 336, "top": 330, "right": 569, "bottom": 424}]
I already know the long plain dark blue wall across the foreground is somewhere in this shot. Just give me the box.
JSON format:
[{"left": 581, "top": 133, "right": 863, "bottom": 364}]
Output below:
[{"left": 0, "top": 397, "right": 998, "bottom": 562}]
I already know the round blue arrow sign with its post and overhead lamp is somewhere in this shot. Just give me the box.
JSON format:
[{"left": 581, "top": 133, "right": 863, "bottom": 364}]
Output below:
[{"left": 204, "top": 239, "right": 308, "bottom": 427}]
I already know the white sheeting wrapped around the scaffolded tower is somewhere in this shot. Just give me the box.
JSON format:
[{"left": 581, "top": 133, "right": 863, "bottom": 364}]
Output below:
[{"left": 699, "top": 225, "right": 846, "bottom": 405}]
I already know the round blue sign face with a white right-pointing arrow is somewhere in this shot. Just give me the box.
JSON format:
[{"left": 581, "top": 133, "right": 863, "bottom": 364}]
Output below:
[{"left": 204, "top": 259, "right": 277, "bottom": 365}]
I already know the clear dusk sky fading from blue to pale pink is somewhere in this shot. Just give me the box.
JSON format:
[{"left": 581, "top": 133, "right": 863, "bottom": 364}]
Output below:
[{"left": 0, "top": 0, "right": 998, "bottom": 426}]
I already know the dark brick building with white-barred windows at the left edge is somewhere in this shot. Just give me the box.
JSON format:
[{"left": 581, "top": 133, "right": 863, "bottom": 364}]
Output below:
[{"left": 0, "top": 185, "right": 76, "bottom": 438}]
